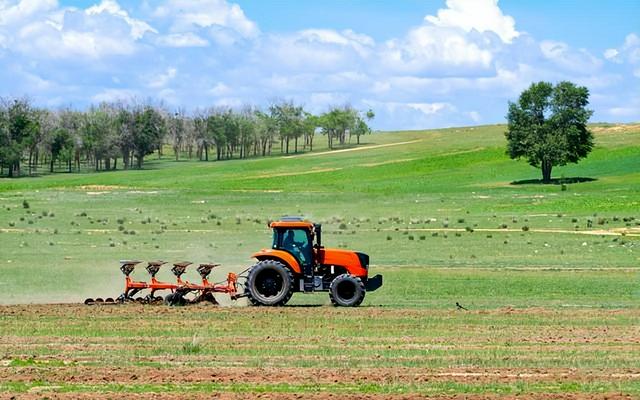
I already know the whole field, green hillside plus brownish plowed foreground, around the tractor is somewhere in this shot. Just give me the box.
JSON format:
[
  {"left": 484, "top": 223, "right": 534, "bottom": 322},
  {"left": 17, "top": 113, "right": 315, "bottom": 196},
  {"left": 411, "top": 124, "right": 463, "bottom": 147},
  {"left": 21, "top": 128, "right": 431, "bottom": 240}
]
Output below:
[{"left": 0, "top": 125, "right": 640, "bottom": 398}]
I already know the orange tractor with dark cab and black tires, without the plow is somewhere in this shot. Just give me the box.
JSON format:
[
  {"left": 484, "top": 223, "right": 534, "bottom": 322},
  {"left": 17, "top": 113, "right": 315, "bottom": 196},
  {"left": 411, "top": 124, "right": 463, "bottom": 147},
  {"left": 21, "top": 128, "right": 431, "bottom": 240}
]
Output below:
[{"left": 244, "top": 217, "right": 382, "bottom": 307}]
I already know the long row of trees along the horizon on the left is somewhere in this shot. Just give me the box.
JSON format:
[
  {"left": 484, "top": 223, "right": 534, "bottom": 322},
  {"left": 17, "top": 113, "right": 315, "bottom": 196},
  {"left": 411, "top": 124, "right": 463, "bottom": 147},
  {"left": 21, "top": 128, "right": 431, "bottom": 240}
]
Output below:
[{"left": 0, "top": 98, "right": 375, "bottom": 177}]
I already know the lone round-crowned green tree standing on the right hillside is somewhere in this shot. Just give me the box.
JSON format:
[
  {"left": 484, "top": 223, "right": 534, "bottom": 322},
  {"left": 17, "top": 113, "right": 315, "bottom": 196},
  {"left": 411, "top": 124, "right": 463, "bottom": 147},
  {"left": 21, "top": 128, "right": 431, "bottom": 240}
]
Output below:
[{"left": 505, "top": 82, "right": 593, "bottom": 183}]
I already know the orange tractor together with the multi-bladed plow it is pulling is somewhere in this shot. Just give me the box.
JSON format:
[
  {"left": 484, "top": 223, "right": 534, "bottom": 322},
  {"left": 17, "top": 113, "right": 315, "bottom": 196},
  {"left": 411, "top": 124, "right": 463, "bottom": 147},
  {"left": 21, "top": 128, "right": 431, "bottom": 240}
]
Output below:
[{"left": 85, "top": 217, "right": 382, "bottom": 307}]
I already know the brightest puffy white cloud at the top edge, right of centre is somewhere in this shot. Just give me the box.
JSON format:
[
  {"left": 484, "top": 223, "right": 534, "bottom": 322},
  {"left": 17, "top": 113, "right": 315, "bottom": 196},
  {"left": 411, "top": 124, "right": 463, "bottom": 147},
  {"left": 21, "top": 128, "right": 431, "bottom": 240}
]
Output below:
[{"left": 425, "top": 0, "right": 520, "bottom": 43}]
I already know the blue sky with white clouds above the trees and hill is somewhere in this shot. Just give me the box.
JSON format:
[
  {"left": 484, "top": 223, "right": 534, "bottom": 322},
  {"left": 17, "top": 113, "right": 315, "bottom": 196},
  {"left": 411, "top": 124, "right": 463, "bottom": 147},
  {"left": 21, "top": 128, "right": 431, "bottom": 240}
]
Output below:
[{"left": 0, "top": 0, "right": 640, "bottom": 129}]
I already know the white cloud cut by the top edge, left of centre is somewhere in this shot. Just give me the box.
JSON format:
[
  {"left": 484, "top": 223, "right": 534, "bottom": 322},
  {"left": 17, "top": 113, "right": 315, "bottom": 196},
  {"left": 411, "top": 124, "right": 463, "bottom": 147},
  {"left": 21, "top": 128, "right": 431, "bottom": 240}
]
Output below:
[{"left": 154, "top": 0, "right": 260, "bottom": 38}]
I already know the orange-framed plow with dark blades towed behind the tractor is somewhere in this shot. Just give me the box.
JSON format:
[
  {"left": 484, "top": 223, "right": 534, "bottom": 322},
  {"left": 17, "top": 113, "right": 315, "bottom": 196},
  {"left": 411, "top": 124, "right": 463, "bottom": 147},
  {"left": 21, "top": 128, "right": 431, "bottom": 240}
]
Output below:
[{"left": 84, "top": 260, "right": 239, "bottom": 306}]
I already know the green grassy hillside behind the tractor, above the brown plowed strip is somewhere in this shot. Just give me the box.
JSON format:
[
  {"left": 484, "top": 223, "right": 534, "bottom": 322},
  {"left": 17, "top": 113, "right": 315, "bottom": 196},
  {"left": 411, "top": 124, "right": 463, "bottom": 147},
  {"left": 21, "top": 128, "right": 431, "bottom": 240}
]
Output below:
[{"left": 0, "top": 122, "right": 640, "bottom": 307}]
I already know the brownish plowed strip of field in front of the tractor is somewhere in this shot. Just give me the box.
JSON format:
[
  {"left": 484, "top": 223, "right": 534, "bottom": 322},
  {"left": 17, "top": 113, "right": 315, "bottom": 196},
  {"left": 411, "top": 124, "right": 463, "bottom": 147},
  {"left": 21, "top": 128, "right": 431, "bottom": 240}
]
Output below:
[{"left": 0, "top": 304, "right": 640, "bottom": 399}]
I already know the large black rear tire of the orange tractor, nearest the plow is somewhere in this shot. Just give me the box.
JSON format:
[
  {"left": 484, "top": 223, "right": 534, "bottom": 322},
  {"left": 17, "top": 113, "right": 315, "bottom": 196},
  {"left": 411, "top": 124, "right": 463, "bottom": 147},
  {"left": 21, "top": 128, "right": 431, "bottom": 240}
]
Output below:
[{"left": 244, "top": 260, "right": 293, "bottom": 306}]
